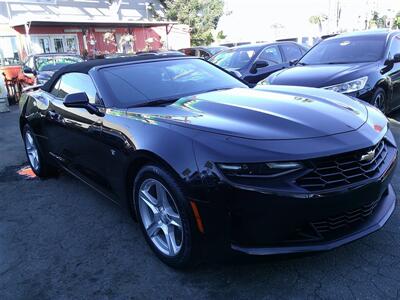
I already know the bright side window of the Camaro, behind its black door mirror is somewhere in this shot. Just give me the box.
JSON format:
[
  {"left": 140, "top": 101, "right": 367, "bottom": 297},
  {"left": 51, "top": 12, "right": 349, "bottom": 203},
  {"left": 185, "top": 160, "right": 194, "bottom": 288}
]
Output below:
[{"left": 58, "top": 73, "right": 96, "bottom": 104}]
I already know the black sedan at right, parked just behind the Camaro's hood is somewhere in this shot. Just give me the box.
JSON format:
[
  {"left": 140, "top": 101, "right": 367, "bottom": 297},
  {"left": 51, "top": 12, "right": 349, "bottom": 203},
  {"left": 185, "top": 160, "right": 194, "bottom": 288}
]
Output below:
[{"left": 261, "top": 29, "right": 400, "bottom": 113}]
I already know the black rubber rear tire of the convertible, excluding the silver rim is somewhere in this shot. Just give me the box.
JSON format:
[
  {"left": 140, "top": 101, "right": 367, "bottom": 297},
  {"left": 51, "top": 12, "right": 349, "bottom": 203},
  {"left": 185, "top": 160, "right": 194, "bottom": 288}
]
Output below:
[{"left": 22, "top": 124, "right": 57, "bottom": 178}]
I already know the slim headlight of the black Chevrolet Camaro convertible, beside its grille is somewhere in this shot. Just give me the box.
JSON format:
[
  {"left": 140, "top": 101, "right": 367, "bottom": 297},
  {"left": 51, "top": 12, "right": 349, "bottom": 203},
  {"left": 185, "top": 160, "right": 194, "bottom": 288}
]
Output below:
[{"left": 217, "top": 162, "right": 303, "bottom": 177}]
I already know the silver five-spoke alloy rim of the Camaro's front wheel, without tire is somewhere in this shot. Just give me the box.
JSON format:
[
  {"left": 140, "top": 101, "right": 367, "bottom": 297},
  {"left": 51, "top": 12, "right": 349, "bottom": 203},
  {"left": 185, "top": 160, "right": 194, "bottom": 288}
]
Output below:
[{"left": 138, "top": 178, "right": 183, "bottom": 257}]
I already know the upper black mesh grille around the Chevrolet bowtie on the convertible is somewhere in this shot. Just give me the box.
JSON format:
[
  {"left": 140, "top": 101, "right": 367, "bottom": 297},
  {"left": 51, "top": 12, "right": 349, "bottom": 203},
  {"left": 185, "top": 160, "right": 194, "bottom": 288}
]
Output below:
[{"left": 296, "top": 140, "right": 388, "bottom": 192}]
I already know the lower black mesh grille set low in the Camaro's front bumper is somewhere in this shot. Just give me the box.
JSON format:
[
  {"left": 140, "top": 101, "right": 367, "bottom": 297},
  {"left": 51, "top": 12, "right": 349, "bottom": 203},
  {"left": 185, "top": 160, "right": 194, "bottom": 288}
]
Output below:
[{"left": 311, "top": 199, "right": 380, "bottom": 235}]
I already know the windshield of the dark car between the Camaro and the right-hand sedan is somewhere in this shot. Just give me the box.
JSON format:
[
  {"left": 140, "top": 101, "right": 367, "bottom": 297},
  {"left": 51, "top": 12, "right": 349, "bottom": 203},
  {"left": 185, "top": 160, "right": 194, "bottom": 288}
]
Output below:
[{"left": 210, "top": 48, "right": 256, "bottom": 69}]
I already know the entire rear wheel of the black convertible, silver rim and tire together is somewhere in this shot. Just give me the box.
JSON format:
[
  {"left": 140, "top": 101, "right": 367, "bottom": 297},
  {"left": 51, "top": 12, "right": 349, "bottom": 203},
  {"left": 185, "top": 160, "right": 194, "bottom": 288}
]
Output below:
[{"left": 23, "top": 124, "right": 56, "bottom": 177}]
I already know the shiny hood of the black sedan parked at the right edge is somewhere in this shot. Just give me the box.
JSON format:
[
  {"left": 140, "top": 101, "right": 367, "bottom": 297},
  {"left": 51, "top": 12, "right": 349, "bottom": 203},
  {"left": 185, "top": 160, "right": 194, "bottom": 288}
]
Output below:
[{"left": 269, "top": 63, "right": 377, "bottom": 88}]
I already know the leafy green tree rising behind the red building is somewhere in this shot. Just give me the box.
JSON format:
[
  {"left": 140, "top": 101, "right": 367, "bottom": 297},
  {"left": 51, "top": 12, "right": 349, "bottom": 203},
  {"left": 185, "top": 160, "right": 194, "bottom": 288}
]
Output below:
[{"left": 160, "top": 0, "right": 224, "bottom": 46}]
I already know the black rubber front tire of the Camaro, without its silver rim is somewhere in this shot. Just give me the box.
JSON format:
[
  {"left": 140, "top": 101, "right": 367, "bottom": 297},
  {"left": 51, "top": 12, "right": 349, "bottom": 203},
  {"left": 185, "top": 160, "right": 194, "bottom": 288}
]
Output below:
[{"left": 133, "top": 165, "right": 199, "bottom": 269}]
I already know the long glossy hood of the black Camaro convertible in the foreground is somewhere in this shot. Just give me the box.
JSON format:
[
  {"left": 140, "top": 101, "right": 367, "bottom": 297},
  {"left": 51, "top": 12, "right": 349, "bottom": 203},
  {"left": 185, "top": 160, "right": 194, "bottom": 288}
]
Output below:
[{"left": 127, "top": 86, "right": 367, "bottom": 140}]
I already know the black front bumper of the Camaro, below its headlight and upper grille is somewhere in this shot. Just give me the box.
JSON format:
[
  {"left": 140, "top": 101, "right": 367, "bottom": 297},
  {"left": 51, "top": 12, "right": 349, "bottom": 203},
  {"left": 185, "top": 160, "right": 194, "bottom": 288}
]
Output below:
[{"left": 198, "top": 140, "right": 397, "bottom": 255}]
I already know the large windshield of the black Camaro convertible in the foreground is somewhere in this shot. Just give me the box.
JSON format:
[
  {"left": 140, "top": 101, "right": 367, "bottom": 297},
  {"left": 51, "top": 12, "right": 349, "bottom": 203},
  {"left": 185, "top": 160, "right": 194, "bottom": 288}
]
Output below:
[{"left": 99, "top": 59, "right": 247, "bottom": 108}]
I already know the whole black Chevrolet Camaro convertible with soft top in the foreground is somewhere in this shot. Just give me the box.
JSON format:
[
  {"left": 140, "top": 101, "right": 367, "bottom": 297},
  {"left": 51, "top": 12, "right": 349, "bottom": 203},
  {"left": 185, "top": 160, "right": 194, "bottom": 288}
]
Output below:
[{"left": 20, "top": 55, "right": 397, "bottom": 267}]
